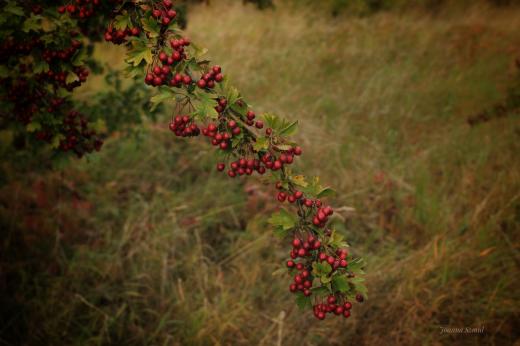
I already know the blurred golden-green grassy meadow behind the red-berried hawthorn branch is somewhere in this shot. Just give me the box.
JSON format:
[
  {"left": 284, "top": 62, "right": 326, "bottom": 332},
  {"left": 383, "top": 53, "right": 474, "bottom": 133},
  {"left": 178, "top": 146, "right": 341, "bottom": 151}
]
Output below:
[{"left": 0, "top": 0, "right": 520, "bottom": 345}]
